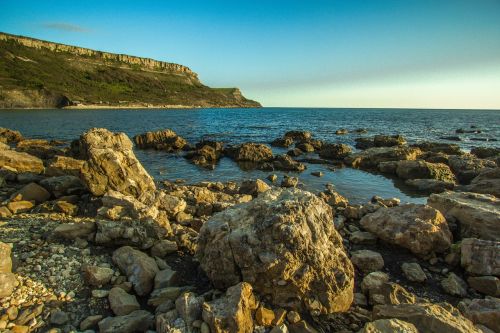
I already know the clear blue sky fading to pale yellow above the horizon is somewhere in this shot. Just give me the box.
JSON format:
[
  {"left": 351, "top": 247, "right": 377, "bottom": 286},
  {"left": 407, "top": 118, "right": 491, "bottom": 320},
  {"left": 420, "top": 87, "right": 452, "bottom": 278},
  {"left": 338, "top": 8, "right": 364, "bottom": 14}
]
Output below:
[{"left": 0, "top": 0, "right": 500, "bottom": 109}]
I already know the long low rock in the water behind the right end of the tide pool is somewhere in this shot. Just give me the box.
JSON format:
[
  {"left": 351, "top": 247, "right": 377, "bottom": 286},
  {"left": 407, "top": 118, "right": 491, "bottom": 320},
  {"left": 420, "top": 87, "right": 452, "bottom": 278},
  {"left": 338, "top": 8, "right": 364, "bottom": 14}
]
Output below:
[{"left": 344, "top": 147, "right": 421, "bottom": 169}]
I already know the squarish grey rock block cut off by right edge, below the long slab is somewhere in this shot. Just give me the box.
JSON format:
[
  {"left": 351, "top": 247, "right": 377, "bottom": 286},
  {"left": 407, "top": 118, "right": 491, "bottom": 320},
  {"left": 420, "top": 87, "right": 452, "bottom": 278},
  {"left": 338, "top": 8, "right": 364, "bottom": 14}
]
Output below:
[{"left": 460, "top": 238, "right": 500, "bottom": 276}]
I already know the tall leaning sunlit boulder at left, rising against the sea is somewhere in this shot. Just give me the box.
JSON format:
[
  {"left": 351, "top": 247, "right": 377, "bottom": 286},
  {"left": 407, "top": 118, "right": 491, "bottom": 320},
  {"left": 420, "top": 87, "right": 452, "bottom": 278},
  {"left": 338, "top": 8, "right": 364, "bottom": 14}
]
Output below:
[{"left": 80, "top": 128, "right": 156, "bottom": 199}]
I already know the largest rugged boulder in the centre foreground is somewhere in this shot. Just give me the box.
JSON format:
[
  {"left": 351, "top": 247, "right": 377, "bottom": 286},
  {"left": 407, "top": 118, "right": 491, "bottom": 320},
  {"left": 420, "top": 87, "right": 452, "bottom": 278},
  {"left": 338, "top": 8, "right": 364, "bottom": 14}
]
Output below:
[{"left": 197, "top": 189, "right": 354, "bottom": 313}]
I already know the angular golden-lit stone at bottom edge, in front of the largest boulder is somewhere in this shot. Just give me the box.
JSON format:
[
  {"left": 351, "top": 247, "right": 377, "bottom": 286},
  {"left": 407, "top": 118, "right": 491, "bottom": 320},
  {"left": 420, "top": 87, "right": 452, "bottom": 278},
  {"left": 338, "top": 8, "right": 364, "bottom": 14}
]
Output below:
[{"left": 202, "top": 282, "right": 257, "bottom": 333}]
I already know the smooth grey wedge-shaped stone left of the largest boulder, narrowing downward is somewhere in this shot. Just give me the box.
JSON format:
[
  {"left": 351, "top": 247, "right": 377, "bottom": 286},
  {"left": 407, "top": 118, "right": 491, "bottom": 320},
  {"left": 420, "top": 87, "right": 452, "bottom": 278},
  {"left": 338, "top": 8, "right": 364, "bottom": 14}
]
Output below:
[{"left": 113, "top": 246, "right": 159, "bottom": 296}]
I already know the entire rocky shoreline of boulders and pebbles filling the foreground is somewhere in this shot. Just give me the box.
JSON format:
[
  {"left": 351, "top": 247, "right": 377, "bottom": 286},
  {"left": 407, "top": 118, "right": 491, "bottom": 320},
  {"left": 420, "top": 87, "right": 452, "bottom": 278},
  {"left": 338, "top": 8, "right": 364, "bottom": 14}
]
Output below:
[{"left": 0, "top": 129, "right": 500, "bottom": 333}]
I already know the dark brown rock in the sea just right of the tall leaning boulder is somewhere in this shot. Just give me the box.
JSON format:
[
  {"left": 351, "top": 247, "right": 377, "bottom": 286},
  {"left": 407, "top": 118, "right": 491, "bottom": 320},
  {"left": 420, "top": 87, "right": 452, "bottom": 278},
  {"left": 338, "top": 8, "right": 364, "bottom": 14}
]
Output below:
[{"left": 134, "top": 129, "right": 187, "bottom": 152}]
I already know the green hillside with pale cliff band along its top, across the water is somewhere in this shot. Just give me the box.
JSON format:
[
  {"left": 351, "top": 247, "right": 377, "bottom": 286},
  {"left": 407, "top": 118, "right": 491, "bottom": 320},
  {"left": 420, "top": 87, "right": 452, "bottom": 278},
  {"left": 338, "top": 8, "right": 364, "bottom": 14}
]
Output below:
[{"left": 0, "top": 33, "right": 260, "bottom": 108}]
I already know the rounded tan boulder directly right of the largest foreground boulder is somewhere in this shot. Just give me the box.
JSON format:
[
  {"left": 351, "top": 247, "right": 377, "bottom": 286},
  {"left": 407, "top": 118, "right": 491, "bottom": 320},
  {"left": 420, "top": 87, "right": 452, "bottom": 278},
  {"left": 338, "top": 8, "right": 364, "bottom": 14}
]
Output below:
[{"left": 360, "top": 204, "right": 452, "bottom": 256}]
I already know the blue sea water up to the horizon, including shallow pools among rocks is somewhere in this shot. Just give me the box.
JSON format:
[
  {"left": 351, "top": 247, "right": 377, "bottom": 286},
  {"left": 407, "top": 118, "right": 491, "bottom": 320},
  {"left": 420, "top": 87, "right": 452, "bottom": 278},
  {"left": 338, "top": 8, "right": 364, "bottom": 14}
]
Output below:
[{"left": 0, "top": 108, "right": 500, "bottom": 203}]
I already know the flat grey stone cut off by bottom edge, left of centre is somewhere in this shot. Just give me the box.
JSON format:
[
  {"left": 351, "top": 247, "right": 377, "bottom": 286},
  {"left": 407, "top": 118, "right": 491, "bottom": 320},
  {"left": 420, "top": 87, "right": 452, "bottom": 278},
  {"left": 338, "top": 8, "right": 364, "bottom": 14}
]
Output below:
[{"left": 98, "top": 310, "right": 154, "bottom": 333}]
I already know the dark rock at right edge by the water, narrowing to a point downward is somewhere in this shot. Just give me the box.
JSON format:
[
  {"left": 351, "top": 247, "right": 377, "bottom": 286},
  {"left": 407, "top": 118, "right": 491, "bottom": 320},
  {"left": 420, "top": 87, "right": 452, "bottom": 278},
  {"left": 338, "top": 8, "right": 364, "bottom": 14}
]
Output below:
[{"left": 448, "top": 154, "right": 497, "bottom": 184}]
